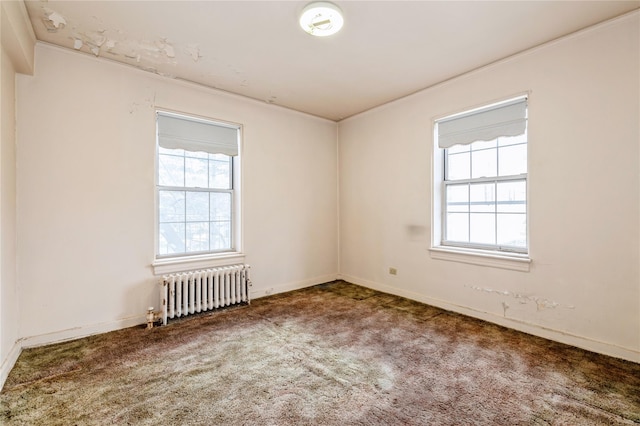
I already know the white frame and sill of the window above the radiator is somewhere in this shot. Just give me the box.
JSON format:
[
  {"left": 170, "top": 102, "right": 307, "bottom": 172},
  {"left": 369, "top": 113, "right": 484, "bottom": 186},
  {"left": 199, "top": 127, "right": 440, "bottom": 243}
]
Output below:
[{"left": 152, "top": 109, "right": 245, "bottom": 275}]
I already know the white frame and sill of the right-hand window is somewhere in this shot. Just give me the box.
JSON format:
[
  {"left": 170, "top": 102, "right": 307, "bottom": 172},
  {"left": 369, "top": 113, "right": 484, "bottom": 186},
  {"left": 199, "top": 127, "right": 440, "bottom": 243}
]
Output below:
[{"left": 429, "top": 94, "right": 531, "bottom": 272}]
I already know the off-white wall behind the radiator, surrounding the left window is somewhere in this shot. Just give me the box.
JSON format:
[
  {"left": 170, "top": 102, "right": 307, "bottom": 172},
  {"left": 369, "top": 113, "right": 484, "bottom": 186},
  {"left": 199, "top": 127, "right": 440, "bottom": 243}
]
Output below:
[{"left": 17, "top": 44, "right": 338, "bottom": 344}]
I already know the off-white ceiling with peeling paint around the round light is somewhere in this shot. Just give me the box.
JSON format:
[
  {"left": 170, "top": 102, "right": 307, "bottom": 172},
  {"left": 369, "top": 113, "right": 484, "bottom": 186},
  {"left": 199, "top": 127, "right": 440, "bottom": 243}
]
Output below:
[{"left": 25, "top": 0, "right": 640, "bottom": 121}]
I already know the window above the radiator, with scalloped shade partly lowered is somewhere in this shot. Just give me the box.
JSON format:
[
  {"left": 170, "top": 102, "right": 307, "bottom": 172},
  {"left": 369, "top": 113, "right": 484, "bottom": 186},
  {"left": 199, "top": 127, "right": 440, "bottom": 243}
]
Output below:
[{"left": 156, "top": 112, "right": 239, "bottom": 258}]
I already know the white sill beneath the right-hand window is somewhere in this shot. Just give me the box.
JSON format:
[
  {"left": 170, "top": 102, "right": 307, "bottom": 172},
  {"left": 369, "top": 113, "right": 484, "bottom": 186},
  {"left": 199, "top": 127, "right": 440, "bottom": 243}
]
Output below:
[{"left": 429, "top": 246, "right": 531, "bottom": 272}]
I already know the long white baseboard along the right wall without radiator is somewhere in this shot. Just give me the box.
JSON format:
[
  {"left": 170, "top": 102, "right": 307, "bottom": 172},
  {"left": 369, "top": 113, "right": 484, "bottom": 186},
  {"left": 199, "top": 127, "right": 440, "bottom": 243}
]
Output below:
[{"left": 341, "top": 275, "right": 640, "bottom": 363}]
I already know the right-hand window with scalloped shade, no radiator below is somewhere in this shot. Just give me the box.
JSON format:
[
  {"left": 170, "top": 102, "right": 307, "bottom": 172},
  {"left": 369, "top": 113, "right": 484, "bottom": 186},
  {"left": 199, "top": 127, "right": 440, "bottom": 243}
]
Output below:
[{"left": 434, "top": 98, "right": 528, "bottom": 254}]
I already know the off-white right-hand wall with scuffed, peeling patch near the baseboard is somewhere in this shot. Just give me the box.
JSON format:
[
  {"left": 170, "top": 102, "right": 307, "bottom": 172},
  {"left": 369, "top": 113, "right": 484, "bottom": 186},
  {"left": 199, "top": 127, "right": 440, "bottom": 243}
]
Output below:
[{"left": 339, "top": 13, "right": 640, "bottom": 361}]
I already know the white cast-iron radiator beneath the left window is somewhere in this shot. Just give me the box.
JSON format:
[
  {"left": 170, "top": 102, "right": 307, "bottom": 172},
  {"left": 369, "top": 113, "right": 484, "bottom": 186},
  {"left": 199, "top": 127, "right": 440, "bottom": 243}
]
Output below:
[{"left": 160, "top": 265, "right": 251, "bottom": 325}]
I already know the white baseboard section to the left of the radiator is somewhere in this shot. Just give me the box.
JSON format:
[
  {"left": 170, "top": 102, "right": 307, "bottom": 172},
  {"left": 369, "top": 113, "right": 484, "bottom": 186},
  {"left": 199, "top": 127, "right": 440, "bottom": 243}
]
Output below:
[{"left": 18, "top": 315, "right": 147, "bottom": 348}]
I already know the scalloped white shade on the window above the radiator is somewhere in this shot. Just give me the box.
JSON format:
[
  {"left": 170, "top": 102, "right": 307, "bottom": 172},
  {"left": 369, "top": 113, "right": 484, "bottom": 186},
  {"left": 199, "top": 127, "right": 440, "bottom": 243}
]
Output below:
[{"left": 158, "top": 113, "right": 238, "bottom": 156}]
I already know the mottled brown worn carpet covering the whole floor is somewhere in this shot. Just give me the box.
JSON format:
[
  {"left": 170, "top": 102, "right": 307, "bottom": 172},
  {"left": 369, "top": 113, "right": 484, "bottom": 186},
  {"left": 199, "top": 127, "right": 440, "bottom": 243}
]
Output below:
[{"left": 0, "top": 281, "right": 640, "bottom": 425}]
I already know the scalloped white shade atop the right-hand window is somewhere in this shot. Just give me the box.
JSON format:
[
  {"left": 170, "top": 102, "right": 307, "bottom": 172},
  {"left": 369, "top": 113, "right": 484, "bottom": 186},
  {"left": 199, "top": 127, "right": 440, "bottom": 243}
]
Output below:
[{"left": 438, "top": 98, "right": 527, "bottom": 148}]
